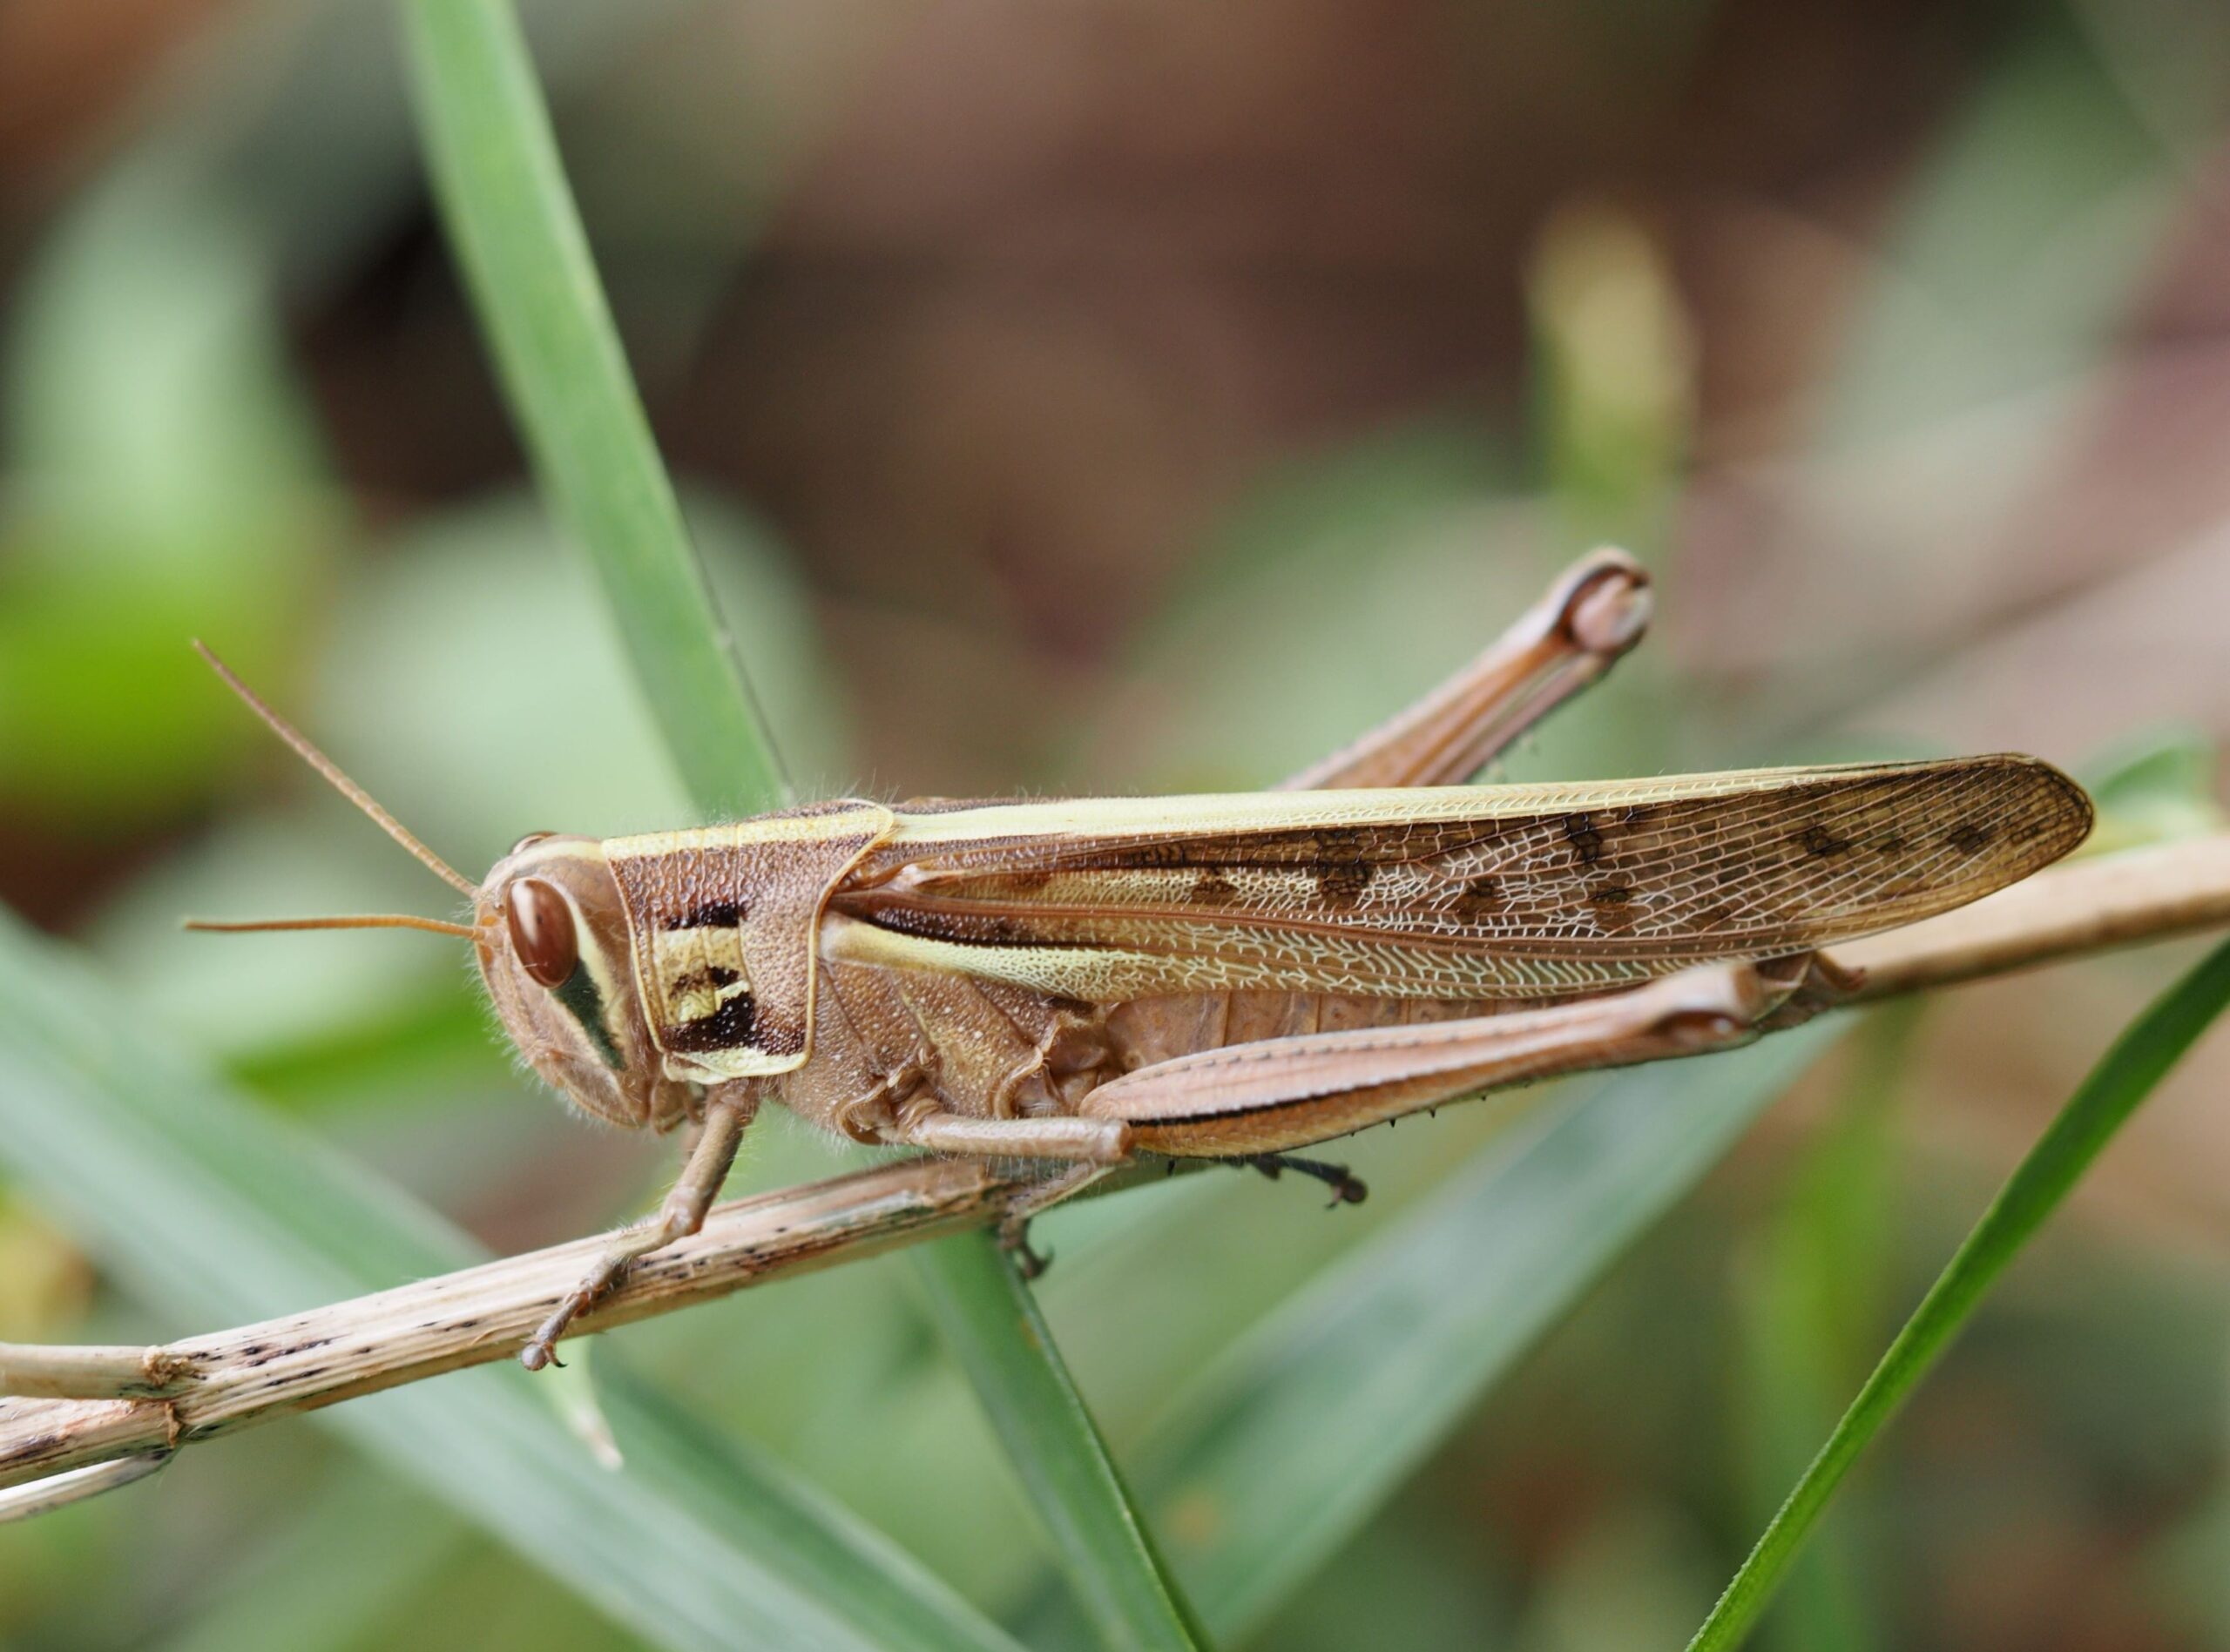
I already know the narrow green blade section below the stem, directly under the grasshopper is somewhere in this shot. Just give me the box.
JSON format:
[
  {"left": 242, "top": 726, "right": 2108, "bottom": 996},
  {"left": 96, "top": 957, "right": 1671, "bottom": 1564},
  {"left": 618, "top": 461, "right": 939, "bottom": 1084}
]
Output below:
[{"left": 915, "top": 1233, "right": 1209, "bottom": 1648}]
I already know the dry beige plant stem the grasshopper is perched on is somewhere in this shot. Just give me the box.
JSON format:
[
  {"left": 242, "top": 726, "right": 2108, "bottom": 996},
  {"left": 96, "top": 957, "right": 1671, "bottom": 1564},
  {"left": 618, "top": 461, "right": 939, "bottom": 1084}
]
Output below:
[{"left": 0, "top": 833, "right": 2230, "bottom": 1514}]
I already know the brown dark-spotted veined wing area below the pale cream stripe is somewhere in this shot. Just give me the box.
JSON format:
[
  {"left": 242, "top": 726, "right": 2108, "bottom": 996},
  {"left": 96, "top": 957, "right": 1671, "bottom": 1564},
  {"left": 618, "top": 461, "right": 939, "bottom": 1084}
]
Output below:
[{"left": 836, "top": 758, "right": 2090, "bottom": 985}]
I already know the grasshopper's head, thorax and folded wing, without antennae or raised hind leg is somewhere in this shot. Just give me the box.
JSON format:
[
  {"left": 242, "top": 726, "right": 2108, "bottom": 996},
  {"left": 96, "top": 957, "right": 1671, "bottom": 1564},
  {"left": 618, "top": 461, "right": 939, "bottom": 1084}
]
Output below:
[{"left": 479, "top": 758, "right": 2087, "bottom": 1159}]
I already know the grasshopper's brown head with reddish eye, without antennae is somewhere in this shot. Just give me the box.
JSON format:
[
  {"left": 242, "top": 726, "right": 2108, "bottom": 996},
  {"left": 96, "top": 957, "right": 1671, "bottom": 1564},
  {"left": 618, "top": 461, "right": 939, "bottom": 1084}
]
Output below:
[{"left": 473, "top": 832, "right": 696, "bottom": 1130}]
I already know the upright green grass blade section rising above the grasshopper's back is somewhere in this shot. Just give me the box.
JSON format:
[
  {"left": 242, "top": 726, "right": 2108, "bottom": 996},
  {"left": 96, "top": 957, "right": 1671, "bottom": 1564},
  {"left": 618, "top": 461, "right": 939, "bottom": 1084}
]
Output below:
[{"left": 403, "top": 0, "right": 787, "bottom": 819}]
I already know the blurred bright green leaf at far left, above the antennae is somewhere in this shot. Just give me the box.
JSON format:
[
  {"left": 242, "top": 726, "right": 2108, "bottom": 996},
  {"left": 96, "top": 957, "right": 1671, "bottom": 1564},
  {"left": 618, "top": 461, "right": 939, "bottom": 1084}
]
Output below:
[{"left": 0, "top": 156, "right": 329, "bottom": 833}]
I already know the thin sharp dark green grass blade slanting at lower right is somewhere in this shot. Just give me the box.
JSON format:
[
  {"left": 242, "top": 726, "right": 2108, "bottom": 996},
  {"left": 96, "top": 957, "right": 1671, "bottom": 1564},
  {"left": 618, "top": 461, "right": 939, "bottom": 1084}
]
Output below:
[{"left": 1688, "top": 943, "right": 2230, "bottom": 1652}]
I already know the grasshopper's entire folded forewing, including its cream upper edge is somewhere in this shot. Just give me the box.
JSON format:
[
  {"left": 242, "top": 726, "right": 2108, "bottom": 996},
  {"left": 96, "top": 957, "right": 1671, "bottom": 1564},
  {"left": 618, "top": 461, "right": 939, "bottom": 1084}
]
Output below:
[{"left": 832, "top": 758, "right": 2090, "bottom": 999}]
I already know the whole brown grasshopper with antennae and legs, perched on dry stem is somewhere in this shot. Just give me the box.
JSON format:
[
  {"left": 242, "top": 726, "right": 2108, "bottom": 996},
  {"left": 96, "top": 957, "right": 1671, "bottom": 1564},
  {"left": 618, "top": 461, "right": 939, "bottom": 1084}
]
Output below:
[{"left": 196, "top": 550, "right": 2091, "bottom": 1369}]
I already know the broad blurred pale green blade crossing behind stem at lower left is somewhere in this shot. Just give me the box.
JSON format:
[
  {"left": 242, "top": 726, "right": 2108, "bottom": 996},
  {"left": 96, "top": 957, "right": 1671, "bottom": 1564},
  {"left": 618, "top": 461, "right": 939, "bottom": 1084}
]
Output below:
[{"left": 0, "top": 919, "right": 1012, "bottom": 1652}]
